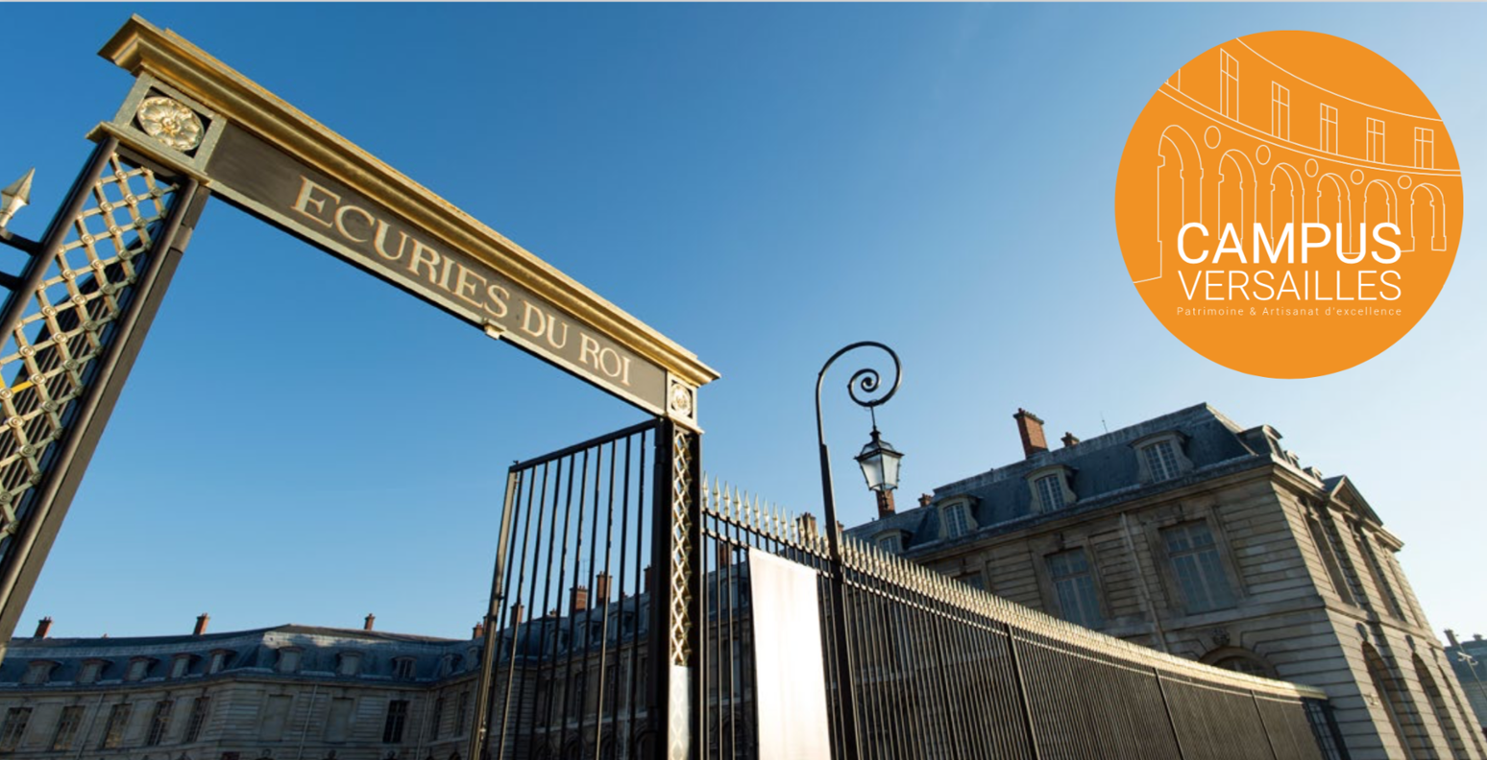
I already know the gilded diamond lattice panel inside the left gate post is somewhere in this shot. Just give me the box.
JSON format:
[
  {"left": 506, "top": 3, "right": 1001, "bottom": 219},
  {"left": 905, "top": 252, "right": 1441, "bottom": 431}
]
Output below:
[{"left": 0, "top": 153, "right": 178, "bottom": 556}]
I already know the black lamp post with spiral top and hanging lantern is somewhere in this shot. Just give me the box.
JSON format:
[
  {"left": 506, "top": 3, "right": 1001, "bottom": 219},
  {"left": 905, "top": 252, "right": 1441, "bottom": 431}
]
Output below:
[{"left": 816, "top": 341, "right": 903, "bottom": 760}]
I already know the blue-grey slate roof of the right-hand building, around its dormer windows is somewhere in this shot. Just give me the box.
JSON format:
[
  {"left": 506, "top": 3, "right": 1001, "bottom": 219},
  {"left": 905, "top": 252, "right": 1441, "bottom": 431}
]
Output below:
[{"left": 848, "top": 403, "right": 1326, "bottom": 555}]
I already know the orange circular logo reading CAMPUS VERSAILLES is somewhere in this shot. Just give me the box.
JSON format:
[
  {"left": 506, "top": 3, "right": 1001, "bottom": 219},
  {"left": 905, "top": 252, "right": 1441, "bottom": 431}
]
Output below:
[{"left": 1115, "top": 31, "right": 1462, "bottom": 378}]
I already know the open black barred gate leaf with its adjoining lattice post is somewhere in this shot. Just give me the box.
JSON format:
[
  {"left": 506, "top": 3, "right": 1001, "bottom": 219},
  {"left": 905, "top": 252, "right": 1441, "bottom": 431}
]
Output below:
[{"left": 470, "top": 419, "right": 697, "bottom": 760}]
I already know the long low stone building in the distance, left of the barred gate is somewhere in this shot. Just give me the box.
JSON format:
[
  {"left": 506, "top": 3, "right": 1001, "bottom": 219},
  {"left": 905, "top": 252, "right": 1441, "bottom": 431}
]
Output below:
[{"left": 0, "top": 616, "right": 480, "bottom": 760}]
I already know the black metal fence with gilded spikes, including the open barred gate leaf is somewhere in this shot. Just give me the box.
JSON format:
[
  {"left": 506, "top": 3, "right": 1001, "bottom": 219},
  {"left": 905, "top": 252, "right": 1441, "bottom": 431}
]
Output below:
[{"left": 471, "top": 421, "right": 1340, "bottom": 760}]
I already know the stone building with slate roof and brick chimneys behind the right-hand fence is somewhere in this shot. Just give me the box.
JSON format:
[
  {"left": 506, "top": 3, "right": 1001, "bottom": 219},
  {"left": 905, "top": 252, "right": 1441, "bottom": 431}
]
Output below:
[{"left": 849, "top": 405, "right": 1487, "bottom": 760}]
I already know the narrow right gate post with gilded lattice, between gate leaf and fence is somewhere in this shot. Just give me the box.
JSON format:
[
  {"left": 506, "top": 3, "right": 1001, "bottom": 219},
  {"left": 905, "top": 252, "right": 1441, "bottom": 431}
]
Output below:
[{"left": 650, "top": 419, "right": 705, "bottom": 760}]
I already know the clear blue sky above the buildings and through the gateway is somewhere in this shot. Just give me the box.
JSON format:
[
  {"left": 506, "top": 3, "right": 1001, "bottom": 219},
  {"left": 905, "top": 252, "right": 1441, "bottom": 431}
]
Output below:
[{"left": 0, "top": 3, "right": 1487, "bottom": 648}]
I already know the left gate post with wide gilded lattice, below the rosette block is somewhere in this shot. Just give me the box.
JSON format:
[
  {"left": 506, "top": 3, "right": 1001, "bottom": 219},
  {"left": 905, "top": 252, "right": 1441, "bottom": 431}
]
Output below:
[{"left": 0, "top": 135, "right": 207, "bottom": 659}]
